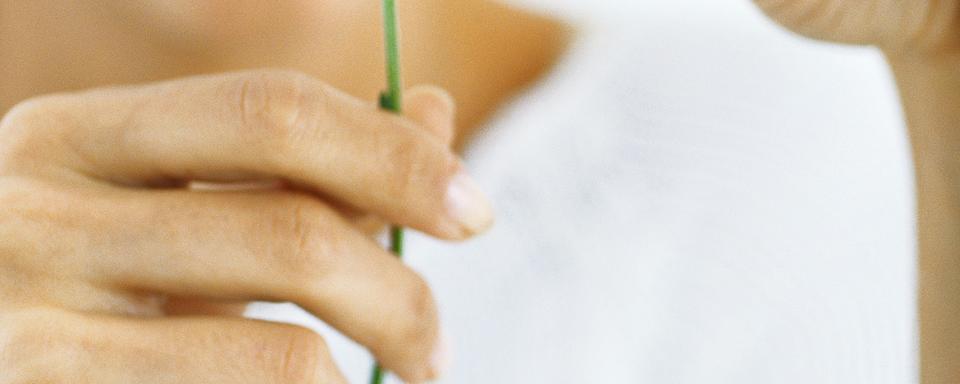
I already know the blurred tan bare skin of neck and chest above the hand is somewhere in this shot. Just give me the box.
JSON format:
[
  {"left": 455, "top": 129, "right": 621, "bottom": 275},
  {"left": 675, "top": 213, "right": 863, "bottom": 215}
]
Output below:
[{"left": 0, "top": 0, "right": 565, "bottom": 137}]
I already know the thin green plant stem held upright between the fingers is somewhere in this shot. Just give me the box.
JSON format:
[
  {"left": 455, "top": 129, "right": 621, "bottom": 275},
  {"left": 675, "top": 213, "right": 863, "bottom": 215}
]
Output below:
[{"left": 370, "top": 0, "right": 403, "bottom": 384}]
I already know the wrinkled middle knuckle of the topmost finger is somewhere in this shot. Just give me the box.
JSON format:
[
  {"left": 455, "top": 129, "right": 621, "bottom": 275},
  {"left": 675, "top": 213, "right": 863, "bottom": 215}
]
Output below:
[{"left": 236, "top": 70, "right": 324, "bottom": 156}]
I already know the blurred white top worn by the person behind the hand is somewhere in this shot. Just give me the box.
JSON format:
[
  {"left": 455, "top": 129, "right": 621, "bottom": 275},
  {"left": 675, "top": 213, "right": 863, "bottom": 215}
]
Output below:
[{"left": 251, "top": 0, "right": 917, "bottom": 384}]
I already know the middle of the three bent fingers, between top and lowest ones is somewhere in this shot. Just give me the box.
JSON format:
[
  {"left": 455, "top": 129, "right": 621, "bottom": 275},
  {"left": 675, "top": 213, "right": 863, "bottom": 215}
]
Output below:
[{"left": 63, "top": 190, "right": 439, "bottom": 381}]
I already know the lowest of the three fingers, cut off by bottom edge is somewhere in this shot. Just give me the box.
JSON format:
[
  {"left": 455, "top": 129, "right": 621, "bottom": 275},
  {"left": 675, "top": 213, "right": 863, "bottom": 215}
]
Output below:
[{"left": 0, "top": 310, "right": 346, "bottom": 384}]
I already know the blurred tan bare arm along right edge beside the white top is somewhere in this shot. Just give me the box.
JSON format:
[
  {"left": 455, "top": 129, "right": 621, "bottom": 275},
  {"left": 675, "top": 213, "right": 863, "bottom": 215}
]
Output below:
[{"left": 888, "top": 54, "right": 960, "bottom": 384}]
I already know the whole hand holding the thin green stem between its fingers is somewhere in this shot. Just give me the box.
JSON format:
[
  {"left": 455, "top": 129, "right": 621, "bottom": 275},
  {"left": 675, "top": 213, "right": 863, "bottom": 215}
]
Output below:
[{"left": 0, "top": 71, "right": 491, "bottom": 384}]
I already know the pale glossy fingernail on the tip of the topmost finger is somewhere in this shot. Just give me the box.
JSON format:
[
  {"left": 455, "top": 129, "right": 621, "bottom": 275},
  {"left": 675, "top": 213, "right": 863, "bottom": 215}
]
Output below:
[{"left": 447, "top": 172, "right": 493, "bottom": 236}]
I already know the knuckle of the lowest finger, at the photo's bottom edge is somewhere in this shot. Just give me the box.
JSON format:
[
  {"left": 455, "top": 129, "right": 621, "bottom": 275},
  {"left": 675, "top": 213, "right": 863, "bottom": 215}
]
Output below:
[{"left": 272, "top": 327, "right": 326, "bottom": 383}]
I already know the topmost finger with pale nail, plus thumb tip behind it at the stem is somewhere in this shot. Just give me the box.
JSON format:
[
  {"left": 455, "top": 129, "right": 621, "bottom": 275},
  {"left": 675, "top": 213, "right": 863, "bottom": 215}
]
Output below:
[{"left": 5, "top": 72, "right": 492, "bottom": 239}]
